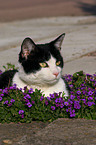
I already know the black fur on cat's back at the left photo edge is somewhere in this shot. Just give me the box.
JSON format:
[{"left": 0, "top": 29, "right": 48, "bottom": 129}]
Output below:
[{"left": 0, "top": 70, "right": 18, "bottom": 89}]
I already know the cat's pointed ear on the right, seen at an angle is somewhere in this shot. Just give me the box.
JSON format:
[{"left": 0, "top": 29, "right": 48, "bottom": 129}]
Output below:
[{"left": 52, "top": 33, "right": 65, "bottom": 51}]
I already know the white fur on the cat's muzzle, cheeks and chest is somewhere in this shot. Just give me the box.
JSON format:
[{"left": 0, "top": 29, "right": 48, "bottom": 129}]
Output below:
[{"left": 13, "top": 56, "right": 68, "bottom": 97}]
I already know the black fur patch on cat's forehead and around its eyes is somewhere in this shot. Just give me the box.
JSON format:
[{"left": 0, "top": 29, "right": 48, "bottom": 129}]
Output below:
[{"left": 19, "top": 43, "right": 63, "bottom": 73}]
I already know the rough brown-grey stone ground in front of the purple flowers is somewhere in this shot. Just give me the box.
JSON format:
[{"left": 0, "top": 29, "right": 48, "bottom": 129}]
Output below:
[{"left": 0, "top": 118, "right": 96, "bottom": 145}]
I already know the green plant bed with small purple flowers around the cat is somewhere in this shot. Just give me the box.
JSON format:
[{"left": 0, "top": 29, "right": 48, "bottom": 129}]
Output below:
[{"left": 0, "top": 65, "right": 96, "bottom": 123}]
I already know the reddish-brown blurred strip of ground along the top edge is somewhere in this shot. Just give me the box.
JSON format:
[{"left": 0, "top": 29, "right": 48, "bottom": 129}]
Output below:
[{"left": 0, "top": 0, "right": 96, "bottom": 22}]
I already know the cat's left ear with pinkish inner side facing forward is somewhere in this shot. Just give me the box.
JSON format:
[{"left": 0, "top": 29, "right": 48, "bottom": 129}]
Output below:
[{"left": 21, "top": 37, "right": 36, "bottom": 59}]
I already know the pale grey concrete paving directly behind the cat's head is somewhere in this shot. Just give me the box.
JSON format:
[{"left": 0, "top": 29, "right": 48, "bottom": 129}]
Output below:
[{"left": 0, "top": 16, "right": 96, "bottom": 74}]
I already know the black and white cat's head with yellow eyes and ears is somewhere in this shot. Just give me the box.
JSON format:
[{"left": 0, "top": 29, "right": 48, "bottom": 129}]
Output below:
[{"left": 19, "top": 33, "right": 65, "bottom": 84}]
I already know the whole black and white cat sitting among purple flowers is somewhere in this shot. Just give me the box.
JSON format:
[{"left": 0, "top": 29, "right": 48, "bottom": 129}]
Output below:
[{"left": 0, "top": 33, "right": 68, "bottom": 97}]
